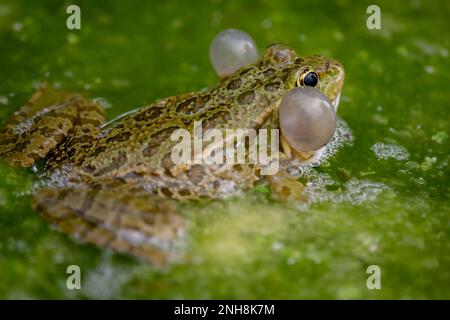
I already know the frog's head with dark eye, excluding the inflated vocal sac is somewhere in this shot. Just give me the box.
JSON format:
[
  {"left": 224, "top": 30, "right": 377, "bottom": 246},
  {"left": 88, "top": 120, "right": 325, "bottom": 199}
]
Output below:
[{"left": 262, "top": 44, "right": 344, "bottom": 109}]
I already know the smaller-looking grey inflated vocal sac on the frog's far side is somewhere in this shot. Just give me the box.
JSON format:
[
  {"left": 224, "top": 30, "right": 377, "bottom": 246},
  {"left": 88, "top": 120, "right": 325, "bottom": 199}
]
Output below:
[{"left": 209, "top": 29, "right": 258, "bottom": 78}]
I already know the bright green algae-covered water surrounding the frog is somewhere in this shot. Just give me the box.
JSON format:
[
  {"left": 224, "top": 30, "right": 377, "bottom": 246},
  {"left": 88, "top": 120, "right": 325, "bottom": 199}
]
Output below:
[{"left": 0, "top": 0, "right": 450, "bottom": 299}]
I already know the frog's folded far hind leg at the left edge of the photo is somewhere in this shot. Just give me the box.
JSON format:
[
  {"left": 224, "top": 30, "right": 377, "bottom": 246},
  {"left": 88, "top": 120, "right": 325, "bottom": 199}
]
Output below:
[{"left": 0, "top": 84, "right": 104, "bottom": 167}]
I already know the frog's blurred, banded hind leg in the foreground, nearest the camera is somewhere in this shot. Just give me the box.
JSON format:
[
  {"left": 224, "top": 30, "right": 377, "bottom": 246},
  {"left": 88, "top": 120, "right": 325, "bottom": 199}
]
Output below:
[{"left": 33, "top": 188, "right": 185, "bottom": 266}]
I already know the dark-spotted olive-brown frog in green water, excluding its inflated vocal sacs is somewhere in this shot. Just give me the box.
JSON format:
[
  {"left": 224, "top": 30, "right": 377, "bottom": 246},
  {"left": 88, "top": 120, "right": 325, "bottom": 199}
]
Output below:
[{"left": 0, "top": 44, "right": 344, "bottom": 266}]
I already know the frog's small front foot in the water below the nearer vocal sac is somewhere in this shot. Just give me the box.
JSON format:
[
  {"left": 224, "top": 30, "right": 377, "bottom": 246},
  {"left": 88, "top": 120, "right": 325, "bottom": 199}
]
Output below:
[{"left": 268, "top": 170, "right": 307, "bottom": 202}]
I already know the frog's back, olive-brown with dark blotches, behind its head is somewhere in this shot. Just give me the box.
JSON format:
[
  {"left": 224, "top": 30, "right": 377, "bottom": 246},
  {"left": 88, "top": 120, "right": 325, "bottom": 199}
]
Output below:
[{"left": 78, "top": 57, "right": 296, "bottom": 180}]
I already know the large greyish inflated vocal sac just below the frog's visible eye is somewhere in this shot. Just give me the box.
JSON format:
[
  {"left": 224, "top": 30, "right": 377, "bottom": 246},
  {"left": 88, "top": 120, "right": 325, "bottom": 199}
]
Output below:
[{"left": 279, "top": 87, "right": 336, "bottom": 152}]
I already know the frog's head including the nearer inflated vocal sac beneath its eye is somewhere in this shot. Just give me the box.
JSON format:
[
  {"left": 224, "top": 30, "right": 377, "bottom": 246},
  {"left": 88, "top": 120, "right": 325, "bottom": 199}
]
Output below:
[{"left": 262, "top": 44, "right": 344, "bottom": 160}]
